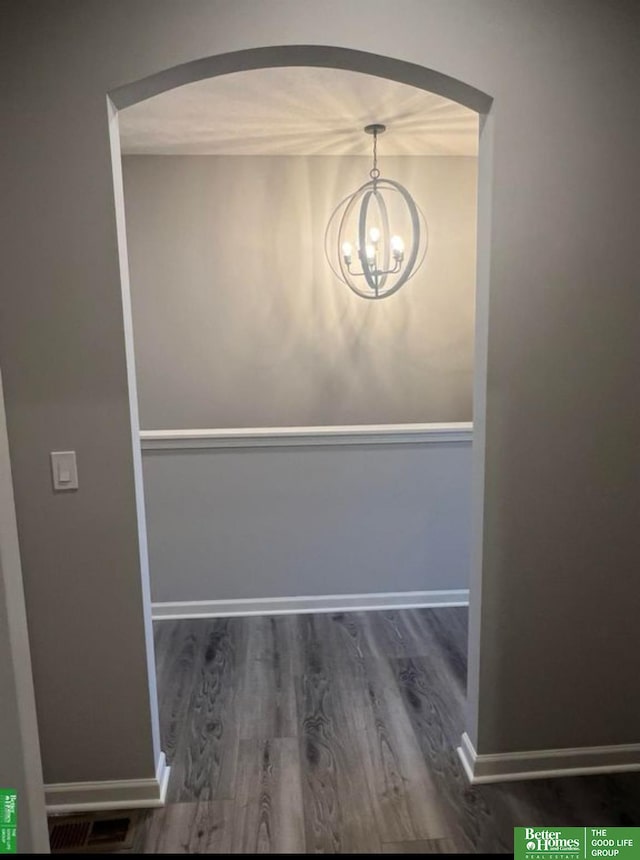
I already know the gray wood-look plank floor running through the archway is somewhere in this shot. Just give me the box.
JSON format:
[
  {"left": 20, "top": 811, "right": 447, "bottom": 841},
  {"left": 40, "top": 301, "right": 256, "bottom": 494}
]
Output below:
[{"left": 134, "top": 608, "right": 640, "bottom": 854}]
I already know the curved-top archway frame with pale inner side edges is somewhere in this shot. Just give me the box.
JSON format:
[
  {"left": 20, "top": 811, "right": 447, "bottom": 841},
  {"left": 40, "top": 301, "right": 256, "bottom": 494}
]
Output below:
[{"left": 108, "top": 38, "right": 493, "bottom": 792}]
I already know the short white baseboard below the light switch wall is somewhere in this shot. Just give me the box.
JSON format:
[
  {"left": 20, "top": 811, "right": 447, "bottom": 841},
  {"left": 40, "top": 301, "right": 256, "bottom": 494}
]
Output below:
[{"left": 44, "top": 753, "right": 171, "bottom": 815}]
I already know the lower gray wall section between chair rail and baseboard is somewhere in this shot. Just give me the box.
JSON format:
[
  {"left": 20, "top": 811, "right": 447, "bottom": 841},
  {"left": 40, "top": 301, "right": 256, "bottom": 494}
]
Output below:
[{"left": 143, "top": 442, "right": 471, "bottom": 602}]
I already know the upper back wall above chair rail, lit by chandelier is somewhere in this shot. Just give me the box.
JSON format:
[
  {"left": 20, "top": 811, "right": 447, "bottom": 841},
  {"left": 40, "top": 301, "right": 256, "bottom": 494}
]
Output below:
[{"left": 123, "top": 156, "right": 477, "bottom": 429}]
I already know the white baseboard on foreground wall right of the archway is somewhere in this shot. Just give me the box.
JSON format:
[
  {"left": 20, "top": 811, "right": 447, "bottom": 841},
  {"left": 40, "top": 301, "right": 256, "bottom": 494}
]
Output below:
[{"left": 458, "top": 732, "right": 640, "bottom": 785}]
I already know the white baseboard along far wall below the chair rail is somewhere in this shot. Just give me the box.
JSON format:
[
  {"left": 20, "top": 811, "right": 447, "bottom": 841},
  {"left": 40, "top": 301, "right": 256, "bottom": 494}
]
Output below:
[{"left": 151, "top": 588, "right": 469, "bottom": 621}]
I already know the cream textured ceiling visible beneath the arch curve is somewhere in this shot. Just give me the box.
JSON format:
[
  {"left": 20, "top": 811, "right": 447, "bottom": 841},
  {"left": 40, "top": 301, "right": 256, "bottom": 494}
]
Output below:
[{"left": 120, "top": 67, "right": 478, "bottom": 156}]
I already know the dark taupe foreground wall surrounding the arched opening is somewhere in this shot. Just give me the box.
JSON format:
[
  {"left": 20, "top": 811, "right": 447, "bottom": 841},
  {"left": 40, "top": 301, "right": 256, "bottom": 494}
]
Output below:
[{"left": 0, "top": 0, "right": 640, "bottom": 792}]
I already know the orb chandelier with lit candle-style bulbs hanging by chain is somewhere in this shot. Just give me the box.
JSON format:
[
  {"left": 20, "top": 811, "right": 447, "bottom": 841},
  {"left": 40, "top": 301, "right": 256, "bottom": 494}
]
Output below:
[{"left": 325, "top": 123, "right": 428, "bottom": 299}]
